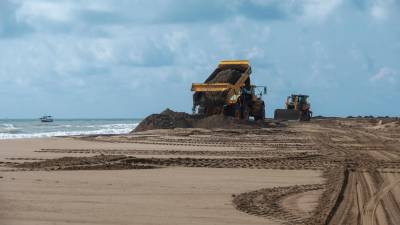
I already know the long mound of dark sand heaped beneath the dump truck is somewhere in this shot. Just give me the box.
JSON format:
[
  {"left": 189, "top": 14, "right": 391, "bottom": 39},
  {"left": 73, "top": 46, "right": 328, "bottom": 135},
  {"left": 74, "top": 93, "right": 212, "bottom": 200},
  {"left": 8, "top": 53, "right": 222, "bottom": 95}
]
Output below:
[{"left": 132, "top": 109, "right": 272, "bottom": 132}]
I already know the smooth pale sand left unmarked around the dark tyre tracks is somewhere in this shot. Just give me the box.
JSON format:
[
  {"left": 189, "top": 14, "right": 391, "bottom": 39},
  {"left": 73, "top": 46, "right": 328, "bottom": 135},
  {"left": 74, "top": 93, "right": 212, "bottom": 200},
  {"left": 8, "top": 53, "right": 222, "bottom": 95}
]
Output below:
[{"left": 0, "top": 138, "right": 322, "bottom": 225}]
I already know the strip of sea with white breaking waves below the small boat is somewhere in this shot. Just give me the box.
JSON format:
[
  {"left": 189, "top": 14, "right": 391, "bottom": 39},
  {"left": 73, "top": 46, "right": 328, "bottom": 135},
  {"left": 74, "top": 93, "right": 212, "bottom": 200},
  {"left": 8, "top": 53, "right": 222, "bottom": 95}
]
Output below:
[{"left": 0, "top": 119, "right": 141, "bottom": 139}]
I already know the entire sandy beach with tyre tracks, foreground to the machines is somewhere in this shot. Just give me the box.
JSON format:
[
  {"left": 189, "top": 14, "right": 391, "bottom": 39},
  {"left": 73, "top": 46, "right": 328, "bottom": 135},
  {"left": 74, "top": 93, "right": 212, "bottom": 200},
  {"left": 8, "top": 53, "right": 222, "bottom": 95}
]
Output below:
[{"left": 0, "top": 119, "right": 400, "bottom": 225}]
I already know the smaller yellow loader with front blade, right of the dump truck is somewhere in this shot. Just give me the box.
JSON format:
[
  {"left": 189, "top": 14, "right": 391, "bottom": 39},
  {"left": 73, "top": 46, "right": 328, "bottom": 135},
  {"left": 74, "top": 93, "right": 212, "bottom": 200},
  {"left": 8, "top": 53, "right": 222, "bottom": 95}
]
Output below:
[{"left": 274, "top": 94, "right": 312, "bottom": 121}]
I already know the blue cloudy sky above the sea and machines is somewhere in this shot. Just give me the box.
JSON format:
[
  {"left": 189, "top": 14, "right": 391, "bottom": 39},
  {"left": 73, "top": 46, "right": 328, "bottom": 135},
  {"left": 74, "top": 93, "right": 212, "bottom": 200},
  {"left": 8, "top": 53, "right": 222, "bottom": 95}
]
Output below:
[{"left": 0, "top": 0, "right": 400, "bottom": 118}]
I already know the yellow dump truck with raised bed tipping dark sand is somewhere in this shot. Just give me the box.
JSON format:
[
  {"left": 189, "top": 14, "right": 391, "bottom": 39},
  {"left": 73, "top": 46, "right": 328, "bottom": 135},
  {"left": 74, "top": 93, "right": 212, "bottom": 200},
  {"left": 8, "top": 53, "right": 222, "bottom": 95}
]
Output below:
[{"left": 192, "top": 60, "right": 267, "bottom": 120}]
